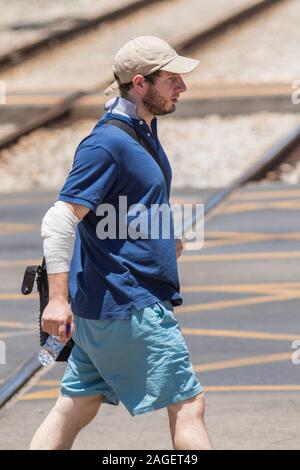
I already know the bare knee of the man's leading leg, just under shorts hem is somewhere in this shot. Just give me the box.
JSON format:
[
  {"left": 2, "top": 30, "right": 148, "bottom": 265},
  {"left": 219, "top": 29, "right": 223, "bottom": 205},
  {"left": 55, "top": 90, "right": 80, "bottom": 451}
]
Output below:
[{"left": 168, "top": 393, "right": 205, "bottom": 420}]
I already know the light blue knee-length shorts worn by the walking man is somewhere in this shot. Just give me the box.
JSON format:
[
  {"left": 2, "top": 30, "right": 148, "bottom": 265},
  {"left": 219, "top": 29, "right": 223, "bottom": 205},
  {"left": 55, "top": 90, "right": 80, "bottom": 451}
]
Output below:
[{"left": 61, "top": 301, "right": 203, "bottom": 416}]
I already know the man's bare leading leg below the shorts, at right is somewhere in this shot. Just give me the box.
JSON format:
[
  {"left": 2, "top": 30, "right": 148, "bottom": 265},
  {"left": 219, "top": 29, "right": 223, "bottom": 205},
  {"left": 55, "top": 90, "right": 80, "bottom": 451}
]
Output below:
[{"left": 168, "top": 393, "right": 212, "bottom": 450}]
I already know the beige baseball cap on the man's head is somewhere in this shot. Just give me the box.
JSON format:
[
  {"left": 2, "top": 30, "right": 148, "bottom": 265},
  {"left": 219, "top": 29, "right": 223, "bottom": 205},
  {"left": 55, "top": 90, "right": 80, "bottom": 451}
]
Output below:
[{"left": 104, "top": 36, "right": 199, "bottom": 95}]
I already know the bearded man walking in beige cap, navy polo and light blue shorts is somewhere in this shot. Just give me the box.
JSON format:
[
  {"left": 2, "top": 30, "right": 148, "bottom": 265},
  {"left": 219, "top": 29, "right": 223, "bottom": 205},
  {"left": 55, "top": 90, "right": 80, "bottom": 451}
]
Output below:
[{"left": 30, "top": 36, "right": 211, "bottom": 450}]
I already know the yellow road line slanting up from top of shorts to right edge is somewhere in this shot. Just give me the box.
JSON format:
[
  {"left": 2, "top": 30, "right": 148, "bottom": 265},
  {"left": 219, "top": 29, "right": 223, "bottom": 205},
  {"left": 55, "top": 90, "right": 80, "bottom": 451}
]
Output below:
[{"left": 176, "top": 293, "right": 300, "bottom": 315}]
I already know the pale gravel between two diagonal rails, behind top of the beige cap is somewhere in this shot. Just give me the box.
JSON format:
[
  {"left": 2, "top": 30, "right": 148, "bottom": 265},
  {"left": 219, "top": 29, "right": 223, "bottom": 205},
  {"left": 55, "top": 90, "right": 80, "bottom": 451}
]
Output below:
[{"left": 2, "top": 0, "right": 258, "bottom": 93}]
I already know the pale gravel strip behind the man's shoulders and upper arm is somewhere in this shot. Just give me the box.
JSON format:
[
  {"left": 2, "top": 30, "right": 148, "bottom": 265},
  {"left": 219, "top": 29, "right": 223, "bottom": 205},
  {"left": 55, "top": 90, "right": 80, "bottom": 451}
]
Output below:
[{"left": 0, "top": 112, "right": 299, "bottom": 192}]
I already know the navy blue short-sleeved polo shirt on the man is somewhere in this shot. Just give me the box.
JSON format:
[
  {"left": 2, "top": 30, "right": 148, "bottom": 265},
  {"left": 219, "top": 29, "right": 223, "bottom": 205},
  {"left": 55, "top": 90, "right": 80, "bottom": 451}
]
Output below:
[{"left": 59, "top": 100, "right": 182, "bottom": 320}]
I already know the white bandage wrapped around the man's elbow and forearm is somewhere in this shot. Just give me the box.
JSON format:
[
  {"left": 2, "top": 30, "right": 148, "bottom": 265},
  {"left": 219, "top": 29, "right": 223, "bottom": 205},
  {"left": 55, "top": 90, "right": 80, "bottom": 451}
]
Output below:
[{"left": 41, "top": 201, "right": 80, "bottom": 274}]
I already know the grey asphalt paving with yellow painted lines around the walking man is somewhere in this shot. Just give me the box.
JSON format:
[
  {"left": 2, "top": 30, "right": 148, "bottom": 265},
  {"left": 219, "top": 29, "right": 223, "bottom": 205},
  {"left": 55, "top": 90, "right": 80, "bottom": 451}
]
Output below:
[{"left": 0, "top": 183, "right": 300, "bottom": 450}]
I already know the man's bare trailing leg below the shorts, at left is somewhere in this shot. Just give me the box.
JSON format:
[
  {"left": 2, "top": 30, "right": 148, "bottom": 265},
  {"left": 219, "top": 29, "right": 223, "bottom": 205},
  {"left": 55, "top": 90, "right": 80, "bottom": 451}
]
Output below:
[{"left": 30, "top": 395, "right": 103, "bottom": 450}]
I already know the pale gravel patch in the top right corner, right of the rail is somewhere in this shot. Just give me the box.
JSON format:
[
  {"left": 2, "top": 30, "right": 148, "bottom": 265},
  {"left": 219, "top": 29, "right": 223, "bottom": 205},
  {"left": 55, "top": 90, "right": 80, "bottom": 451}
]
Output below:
[{"left": 191, "top": 0, "right": 300, "bottom": 86}]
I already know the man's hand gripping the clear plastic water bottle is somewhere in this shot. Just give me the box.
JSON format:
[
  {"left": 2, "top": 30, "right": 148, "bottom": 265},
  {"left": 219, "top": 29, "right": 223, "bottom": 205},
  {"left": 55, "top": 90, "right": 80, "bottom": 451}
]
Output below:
[{"left": 42, "top": 298, "right": 74, "bottom": 343}]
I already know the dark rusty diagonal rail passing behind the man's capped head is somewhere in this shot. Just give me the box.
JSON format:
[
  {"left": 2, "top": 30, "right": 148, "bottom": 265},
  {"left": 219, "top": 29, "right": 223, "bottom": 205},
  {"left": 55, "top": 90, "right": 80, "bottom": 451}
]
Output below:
[{"left": 0, "top": 0, "right": 286, "bottom": 152}]
